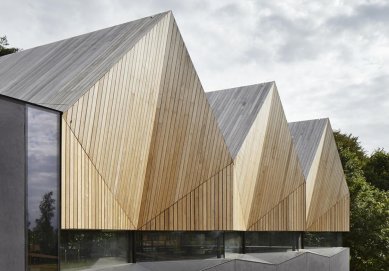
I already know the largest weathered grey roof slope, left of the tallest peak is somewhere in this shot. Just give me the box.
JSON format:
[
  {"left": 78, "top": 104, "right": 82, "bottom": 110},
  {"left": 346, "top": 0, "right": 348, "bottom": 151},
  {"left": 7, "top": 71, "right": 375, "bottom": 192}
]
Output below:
[{"left": 0, "top": 12, "right": 168, "bottom": 111}]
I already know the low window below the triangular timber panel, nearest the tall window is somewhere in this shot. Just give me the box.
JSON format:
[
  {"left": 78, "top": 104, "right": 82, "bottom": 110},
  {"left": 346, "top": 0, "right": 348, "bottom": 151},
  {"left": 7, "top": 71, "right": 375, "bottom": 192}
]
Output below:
[{"left": 60, "top": 230, "right": 129, "bottom": 271}]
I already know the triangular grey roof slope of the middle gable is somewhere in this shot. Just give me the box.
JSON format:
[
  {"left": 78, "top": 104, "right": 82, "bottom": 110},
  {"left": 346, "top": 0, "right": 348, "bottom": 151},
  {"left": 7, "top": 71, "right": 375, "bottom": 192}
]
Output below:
[{"left": 206, "top": 82, "right": 274, "bottom": 158}]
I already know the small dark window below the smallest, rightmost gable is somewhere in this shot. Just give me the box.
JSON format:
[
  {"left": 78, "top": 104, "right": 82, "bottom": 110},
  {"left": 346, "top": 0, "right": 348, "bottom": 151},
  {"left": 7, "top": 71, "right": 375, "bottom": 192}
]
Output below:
[{"left": 303, "top": 232, "right": 342, "bottom": 248}]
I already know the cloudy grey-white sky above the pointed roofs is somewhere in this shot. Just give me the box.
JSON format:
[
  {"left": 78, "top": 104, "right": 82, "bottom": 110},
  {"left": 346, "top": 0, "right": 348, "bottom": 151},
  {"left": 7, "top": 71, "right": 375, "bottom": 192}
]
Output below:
[{"left": 0, "top": 0, "right": 389, "bottom": 153}]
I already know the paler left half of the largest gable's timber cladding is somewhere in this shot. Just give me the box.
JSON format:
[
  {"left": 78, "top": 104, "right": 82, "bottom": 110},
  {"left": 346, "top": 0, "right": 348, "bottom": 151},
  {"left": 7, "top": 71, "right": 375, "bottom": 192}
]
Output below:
[{"left": 62, "top": 16, "right": 170, "bottom": 229}]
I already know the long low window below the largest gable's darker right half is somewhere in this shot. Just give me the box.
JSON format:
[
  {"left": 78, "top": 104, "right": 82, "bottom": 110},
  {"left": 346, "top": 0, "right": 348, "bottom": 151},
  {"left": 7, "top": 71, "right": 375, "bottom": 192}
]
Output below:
[{"left": 136, "top": 232, "right": 223, "bottom": 262}]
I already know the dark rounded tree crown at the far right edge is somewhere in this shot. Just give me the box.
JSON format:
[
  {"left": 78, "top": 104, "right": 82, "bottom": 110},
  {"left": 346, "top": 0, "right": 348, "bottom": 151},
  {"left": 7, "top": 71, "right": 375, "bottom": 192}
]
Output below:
[{"left": 364, "top": 149, "right": 389, "bottom": 191}]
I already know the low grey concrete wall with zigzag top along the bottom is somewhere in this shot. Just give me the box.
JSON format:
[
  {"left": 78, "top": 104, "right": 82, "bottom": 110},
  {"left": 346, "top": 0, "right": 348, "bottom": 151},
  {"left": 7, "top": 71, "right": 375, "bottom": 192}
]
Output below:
[{"left": 76, "top": 248, "right": 350, "bottom": 271}]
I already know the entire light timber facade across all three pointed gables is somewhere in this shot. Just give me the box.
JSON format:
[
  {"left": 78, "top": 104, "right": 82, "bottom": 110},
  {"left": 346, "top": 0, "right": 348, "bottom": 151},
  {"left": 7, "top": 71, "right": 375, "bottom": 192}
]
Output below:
[{"left": 56, "top": 12, "right": 349, "bottom": 231}]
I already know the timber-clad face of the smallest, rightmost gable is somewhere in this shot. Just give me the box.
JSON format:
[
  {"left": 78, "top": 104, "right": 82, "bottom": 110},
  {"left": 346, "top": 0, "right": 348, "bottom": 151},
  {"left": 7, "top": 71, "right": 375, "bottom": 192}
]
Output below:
[{"left": 307, "top": 120, "right": 350, "bottom": 231}]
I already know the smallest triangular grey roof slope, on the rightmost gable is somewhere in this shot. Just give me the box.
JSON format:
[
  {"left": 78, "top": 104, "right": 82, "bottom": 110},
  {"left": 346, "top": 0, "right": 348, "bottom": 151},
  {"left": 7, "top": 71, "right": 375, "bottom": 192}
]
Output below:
[{"left": 288, "top": 118, "right": 328, "bottom": 178}]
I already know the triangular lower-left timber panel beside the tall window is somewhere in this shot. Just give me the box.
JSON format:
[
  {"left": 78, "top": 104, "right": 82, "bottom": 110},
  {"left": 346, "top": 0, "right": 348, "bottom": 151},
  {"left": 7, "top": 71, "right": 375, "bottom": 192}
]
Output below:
[{"left": 61, "top": 120, "right": 135, "bottom": 230}]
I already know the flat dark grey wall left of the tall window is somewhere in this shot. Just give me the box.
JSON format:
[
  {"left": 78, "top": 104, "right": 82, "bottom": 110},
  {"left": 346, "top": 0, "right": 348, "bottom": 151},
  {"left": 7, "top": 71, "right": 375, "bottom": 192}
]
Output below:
[{"left": 0, "top": 96, "right": 26, "bottom": 271}]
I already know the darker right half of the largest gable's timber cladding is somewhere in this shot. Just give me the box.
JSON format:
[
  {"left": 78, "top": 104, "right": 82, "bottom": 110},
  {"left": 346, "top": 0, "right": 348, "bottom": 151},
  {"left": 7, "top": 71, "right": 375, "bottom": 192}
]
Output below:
[{"left": 138, "top": 12, "right": 232, "bottom": 230}]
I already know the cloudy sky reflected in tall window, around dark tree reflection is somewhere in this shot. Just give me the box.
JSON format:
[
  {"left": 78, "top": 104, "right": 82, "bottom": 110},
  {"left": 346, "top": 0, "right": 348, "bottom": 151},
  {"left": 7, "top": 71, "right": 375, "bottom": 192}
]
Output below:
[{"left": 27, "top": 106, "right": 59, "bottom": 229}]
